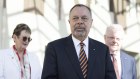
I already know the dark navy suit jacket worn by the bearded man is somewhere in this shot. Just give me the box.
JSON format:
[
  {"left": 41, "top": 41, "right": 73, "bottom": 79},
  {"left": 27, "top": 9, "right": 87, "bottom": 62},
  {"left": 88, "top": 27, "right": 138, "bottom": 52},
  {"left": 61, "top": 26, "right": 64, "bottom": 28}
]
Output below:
[{"left": 41, "top": 35, "right": 116, "bottom": 79}]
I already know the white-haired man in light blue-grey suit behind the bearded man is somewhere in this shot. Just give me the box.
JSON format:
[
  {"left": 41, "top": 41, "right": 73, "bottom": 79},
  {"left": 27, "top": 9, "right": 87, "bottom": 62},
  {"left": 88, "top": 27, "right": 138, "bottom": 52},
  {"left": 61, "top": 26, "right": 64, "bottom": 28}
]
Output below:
[{"left": 104, "top": 24, "right": 137, "bottom": 79}]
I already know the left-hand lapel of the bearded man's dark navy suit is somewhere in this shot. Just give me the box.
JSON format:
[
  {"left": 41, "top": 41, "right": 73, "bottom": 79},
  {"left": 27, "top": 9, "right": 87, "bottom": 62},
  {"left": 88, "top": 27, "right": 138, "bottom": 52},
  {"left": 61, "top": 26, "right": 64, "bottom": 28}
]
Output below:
[{"left": 65, "top": 35, "right": 83, "bottom": 79}]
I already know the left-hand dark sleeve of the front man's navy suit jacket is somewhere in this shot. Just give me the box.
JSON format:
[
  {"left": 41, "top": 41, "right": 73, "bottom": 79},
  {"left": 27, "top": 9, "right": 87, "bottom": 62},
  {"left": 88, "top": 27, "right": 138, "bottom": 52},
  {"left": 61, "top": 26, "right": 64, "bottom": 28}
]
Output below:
[{"left": 41, "top": 43, "right": 58, "bottom": 79}]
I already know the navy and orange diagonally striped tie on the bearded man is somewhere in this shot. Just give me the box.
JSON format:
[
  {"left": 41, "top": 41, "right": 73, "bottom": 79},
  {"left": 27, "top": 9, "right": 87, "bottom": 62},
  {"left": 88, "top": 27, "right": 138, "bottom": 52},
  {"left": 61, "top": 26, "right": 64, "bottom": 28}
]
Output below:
[{"left": 79, "top": 42, "right": 88, "bottom": 79}]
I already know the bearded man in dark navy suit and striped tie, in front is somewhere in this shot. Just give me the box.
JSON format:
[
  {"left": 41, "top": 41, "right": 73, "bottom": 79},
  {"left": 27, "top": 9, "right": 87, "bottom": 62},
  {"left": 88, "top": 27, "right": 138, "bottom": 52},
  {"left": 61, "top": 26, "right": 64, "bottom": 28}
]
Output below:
[{"left": 42, "top": 4, "right": 116, "bottom": 79}]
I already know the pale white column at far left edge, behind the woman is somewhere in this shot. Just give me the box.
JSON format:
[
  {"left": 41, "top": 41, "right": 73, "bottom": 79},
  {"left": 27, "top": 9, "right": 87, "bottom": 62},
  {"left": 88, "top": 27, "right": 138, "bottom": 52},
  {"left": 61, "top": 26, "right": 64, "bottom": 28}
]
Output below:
[{"left": 0, "top": 0, "right": 9, "bottom": 49}]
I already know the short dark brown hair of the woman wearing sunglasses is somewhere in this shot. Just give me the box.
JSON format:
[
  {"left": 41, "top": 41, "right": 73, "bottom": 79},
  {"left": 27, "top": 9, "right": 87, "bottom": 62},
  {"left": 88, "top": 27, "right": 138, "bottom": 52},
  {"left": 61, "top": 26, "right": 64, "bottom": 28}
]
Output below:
[{"left": 12, "top": 23, "right": 31, "bottom": 37}]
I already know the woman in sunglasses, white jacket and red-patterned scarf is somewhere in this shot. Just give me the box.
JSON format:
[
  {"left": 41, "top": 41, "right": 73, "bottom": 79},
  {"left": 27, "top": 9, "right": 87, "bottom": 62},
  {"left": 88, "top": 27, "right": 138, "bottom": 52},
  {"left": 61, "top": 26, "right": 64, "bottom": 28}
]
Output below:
[{"left": 0, "top": 24, "right": 41, "bottom": 79}]
